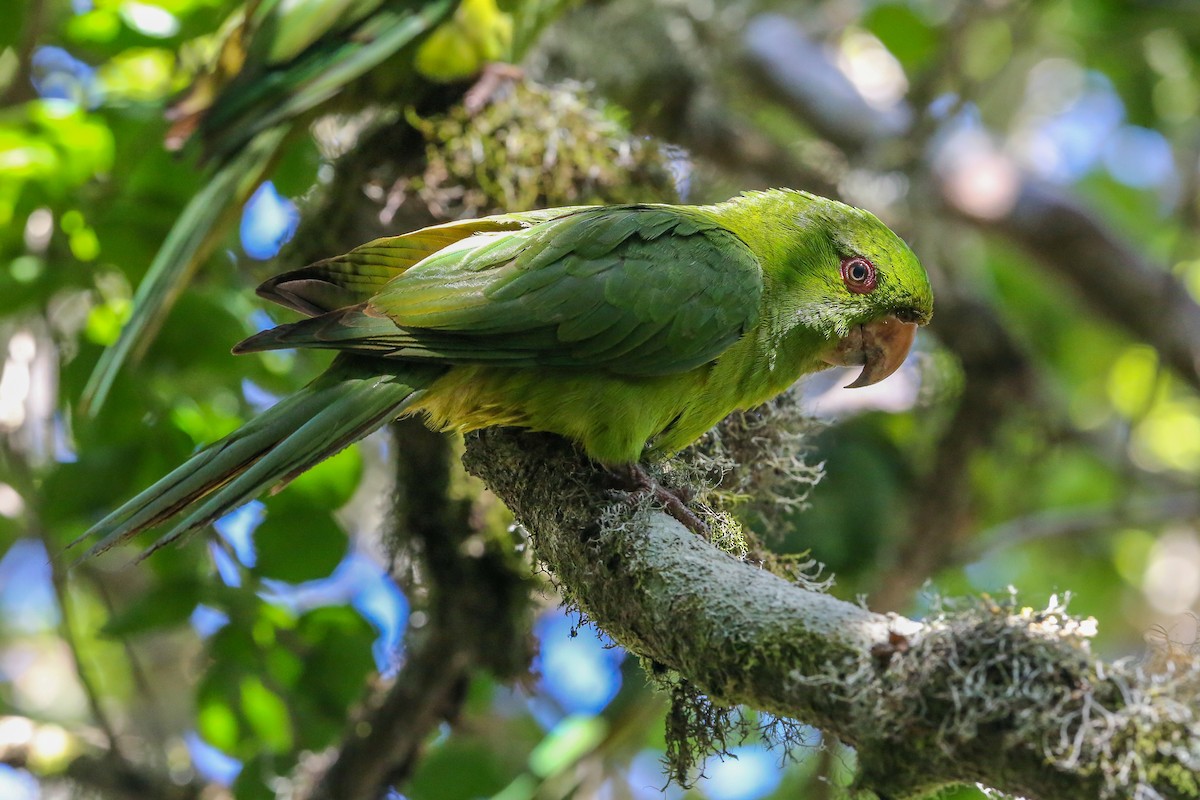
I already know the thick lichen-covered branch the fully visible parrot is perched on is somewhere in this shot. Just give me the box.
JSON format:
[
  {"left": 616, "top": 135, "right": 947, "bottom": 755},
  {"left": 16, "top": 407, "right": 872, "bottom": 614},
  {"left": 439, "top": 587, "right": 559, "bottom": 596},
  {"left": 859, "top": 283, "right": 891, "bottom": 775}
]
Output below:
[{"left": 463, "top": 429, "right": 1200, "bottom": 800}]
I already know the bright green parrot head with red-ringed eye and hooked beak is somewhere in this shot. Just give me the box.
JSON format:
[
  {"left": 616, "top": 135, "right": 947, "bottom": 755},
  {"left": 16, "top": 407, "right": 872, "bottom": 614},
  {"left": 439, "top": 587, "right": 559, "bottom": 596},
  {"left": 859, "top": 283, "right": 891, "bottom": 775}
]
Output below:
[{"left": 793, "top": 198, "right": 934, "bottom": 389}]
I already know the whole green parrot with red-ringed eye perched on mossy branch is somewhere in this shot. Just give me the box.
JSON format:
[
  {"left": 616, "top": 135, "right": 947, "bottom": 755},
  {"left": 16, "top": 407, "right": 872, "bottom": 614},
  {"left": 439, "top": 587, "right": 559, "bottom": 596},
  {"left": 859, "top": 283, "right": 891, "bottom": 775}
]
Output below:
[{"left": 77, "top": 190, "right": 932, "bottom": 561}]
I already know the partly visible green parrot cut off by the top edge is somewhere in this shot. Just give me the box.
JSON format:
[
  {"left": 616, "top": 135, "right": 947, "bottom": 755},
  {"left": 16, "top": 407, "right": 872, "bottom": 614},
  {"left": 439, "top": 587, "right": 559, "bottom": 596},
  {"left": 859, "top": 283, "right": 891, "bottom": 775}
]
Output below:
[{"left": 82, "top": 0, "right": 520, "bottom": 413}]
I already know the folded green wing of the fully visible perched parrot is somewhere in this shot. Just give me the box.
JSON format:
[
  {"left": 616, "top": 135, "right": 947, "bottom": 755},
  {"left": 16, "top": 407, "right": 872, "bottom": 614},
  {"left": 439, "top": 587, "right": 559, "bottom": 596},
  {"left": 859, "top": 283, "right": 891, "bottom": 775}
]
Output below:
[{"left": 238, "top": 206, "right": 762, "bottom": 375}]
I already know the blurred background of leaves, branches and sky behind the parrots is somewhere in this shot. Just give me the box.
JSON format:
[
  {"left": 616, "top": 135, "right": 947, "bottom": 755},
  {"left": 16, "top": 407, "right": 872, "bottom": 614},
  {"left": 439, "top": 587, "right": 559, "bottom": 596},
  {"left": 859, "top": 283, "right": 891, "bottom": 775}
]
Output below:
[{"left": 0, "top": 0, "right": 1200, "bottom": 800}]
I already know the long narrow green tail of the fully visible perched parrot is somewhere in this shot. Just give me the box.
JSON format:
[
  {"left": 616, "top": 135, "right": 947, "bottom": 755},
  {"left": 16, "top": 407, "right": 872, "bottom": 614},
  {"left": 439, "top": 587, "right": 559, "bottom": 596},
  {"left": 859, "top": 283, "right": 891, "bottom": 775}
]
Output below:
[{"left": 71, "top": 356, "right": 445, "bottom": 558}]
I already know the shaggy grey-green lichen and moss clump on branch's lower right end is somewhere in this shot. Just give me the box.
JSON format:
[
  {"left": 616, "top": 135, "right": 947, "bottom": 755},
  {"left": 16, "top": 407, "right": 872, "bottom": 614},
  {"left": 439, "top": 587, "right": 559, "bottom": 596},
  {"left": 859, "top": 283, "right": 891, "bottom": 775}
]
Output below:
[{"left": 836, "top": 595, "right": 1200, "bottom": 800}]
